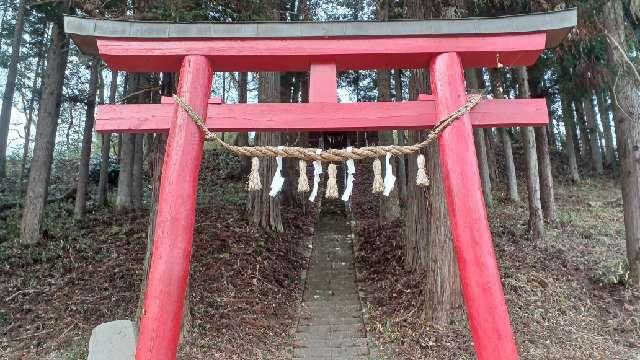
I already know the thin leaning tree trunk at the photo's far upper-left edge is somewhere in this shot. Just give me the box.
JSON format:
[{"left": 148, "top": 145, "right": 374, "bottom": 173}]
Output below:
[{"left": 0, "top": 0, "right": 27, "bottom": 178}]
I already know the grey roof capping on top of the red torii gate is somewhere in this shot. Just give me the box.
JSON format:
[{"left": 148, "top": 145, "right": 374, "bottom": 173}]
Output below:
[{"left": 64, "top": 8, "right": 577, "bottom": 55}]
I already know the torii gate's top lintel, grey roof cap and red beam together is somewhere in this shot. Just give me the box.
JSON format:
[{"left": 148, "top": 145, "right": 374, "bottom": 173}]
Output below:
[{"left": 64, "top": 9, "right": 577, "bottom": 71}]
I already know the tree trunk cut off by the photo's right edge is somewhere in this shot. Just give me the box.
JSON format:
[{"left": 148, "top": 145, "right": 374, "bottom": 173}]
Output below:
[{"left": 603, "top": 0, "right": 640, "bottom": 286}]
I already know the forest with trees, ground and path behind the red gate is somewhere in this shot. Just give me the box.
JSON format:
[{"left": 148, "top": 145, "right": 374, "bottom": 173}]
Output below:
[{"left": 0, "top": 0, "right": 640, "bottom": 360}]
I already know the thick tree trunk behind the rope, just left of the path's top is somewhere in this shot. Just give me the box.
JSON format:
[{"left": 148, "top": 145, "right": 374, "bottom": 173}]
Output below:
[{"left": 247, "top": 72, "right": 284, "bottom": 232}]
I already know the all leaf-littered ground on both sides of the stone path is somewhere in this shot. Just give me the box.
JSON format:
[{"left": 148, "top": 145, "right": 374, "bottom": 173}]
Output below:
[{"left": 0, "top": 150, "right": 640, "bottom": 360}]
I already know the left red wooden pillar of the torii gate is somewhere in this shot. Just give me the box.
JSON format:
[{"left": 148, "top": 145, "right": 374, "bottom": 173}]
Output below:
[{"left": 136, "top": 56, "right": 213, "bottom": 360}]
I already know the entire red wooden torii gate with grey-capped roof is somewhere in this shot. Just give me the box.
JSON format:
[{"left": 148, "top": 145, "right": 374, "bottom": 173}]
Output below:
[{"left": 65, "top": 9, "right": 576, "bottom": 360}]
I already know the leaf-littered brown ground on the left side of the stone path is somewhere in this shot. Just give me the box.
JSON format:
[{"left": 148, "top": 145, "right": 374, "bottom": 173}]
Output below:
[{"left": 0, "top": 155, "right": 313, "bottom": 360}]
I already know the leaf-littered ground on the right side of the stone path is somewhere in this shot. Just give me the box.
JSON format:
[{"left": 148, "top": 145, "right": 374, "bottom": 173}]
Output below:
[{"left": 354, "top": 170, "right": 640, "bottom": 360}]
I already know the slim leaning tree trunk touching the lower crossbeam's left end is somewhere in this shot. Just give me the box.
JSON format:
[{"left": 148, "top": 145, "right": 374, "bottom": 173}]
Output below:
[{"left": 73, "top": 59, "right": 100, "bottom": 220}]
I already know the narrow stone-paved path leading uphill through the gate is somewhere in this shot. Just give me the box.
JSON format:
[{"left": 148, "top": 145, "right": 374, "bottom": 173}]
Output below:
[{"left": 293, "top": 213, "right": 370, "bottom": 360}]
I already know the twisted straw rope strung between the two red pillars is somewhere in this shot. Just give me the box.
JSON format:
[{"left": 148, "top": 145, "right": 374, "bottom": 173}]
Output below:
[{"left": 173, "top": 94, "right": 482, "bottom": 162}]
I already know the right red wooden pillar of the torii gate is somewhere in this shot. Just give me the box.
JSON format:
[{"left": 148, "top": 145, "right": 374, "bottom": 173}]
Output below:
[{"left": 431, "top": 53, "right": 518, "bottom": 360}]
